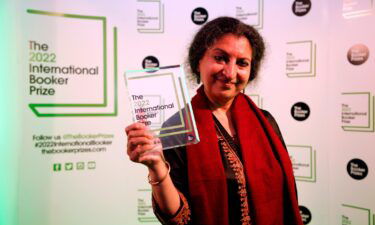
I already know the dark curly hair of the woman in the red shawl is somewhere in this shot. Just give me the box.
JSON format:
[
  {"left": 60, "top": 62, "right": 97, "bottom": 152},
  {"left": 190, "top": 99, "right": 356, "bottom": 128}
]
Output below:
[{"left": 188, "top": 17, "right": 265, "bottom": 83}]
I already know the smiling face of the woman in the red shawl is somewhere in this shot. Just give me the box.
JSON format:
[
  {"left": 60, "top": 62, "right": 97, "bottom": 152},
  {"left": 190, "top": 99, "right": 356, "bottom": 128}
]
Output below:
[{"left": 199, "top": 34, "right": 252, "bottom": 105}]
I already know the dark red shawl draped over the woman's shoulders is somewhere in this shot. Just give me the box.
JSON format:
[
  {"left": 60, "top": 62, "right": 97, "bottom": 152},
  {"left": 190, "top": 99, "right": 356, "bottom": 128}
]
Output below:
[{"left": 187, "top": 86, "right": 302, "bottom": 225}]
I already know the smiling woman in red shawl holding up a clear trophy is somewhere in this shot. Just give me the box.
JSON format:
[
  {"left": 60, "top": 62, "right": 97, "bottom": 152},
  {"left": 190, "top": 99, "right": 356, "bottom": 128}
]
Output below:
[{"left": 126, "top": 17, "right": 302, "bottom": 225}]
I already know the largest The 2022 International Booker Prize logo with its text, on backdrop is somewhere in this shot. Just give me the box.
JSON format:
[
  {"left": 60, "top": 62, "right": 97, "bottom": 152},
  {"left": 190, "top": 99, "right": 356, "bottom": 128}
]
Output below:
[{"left": 26, "top": 9, "right": 117, "bottom": 118}]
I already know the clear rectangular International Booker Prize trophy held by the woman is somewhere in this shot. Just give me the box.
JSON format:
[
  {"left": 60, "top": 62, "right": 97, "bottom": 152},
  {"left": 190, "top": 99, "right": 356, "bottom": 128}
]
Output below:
[{"left": 125, "top": 65, "right": 199, "bottom": 150}]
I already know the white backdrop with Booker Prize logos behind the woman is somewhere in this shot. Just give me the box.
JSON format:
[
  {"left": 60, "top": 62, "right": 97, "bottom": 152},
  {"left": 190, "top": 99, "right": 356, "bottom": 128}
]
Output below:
[{"left": 0, "top": 0, "right": 375, "bottom": 225}]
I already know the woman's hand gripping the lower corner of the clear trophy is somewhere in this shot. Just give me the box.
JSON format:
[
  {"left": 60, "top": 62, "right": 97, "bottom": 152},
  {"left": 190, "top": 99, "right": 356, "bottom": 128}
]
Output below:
[{"left": 125, "top": 123, "right": 164, "bottom": 169}]
